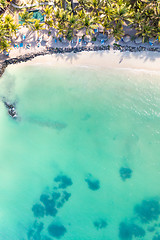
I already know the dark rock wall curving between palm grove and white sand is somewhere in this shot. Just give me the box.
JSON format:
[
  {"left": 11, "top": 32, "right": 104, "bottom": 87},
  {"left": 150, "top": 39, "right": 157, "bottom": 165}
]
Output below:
[{"left": 0, "top": 43, "right": 160, "bottom": 77}]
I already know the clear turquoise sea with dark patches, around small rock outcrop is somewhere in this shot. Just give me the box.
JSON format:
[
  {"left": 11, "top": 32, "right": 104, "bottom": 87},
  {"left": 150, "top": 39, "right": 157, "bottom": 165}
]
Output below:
[{"left": 0, "top": 64, "right": 160, "bottom": 240}]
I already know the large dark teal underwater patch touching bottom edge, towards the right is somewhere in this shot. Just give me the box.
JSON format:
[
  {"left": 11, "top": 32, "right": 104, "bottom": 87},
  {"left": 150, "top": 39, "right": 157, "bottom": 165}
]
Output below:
[{"left": 119, "top": 222, "right": 145, "bottom": 240}]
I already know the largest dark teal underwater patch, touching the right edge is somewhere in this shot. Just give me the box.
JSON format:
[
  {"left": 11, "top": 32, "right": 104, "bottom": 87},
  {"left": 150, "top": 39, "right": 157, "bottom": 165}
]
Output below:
[{"left": 134, "top": 200, "right": 160, "bottom": 223}]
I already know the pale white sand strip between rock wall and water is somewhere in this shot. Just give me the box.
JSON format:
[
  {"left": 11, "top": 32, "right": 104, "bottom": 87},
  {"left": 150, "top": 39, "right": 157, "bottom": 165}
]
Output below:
[{"left": 17, "top": 50, "right": 160, "bottom": 72}]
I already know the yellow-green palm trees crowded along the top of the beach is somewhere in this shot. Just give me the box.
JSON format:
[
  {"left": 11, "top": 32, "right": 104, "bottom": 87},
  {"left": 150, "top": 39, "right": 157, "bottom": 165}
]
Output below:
[{"left": 0, "top": 0, "right": 160, "bottom": 51}]
